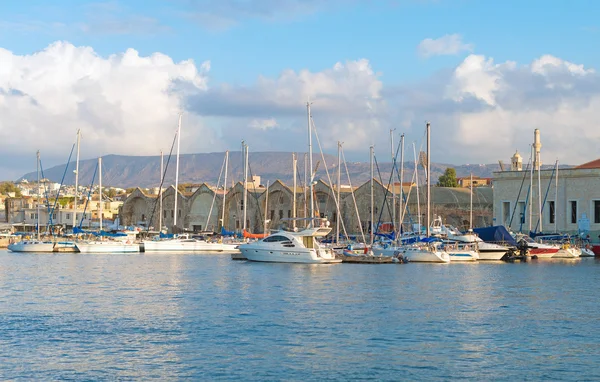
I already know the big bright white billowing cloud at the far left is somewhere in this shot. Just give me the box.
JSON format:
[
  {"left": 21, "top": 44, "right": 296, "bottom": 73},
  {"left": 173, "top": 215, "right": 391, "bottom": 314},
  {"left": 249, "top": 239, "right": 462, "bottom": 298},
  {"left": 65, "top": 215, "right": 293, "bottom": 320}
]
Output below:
[{"left": 0, "top": 42, "right": 215, "bottom": 170}]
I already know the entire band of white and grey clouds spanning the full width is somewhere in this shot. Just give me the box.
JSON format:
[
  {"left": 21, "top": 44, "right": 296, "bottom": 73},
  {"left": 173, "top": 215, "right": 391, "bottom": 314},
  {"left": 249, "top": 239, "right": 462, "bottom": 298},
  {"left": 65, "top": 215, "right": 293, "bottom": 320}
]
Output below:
[{"left": 0, "top": 42, "right": 600, "bottom": 181}]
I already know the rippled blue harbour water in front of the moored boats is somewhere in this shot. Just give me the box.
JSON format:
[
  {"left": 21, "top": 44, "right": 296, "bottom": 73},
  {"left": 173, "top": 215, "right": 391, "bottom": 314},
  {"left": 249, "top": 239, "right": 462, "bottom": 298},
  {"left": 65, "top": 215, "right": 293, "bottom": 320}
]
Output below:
[{"left": 0, "top": 251, "right": 600, "bottom": 381}]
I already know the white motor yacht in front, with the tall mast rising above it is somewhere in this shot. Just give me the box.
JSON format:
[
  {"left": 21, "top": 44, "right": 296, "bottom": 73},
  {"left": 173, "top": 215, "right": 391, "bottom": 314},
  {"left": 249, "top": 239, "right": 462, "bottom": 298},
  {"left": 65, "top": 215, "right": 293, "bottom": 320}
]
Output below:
[{"left": 239, "top": 102, "right": 342, "bottom": 264}]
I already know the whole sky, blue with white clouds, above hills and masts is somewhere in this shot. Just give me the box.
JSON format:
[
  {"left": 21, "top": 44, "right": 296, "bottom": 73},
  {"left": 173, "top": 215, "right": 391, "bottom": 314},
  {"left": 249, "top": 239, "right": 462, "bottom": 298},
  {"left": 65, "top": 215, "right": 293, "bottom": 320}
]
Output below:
[{"left": 0, "top": 0, "right": 600, "bottom": 179}]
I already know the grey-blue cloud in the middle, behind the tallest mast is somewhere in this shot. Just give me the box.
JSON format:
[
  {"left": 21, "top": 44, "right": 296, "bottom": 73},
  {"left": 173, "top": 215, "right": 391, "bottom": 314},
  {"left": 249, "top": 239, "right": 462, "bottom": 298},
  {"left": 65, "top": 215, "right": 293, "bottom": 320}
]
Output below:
[{"left": 188, "top": 59, "right": 386, "bottom": 150}]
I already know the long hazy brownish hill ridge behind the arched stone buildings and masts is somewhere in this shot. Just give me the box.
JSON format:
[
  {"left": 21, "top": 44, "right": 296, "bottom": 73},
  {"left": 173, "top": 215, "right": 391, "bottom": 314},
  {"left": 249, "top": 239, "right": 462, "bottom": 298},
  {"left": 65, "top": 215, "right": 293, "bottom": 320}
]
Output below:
[{"left": 19, "top": 151, "right": 562, "bottom": 188}]
